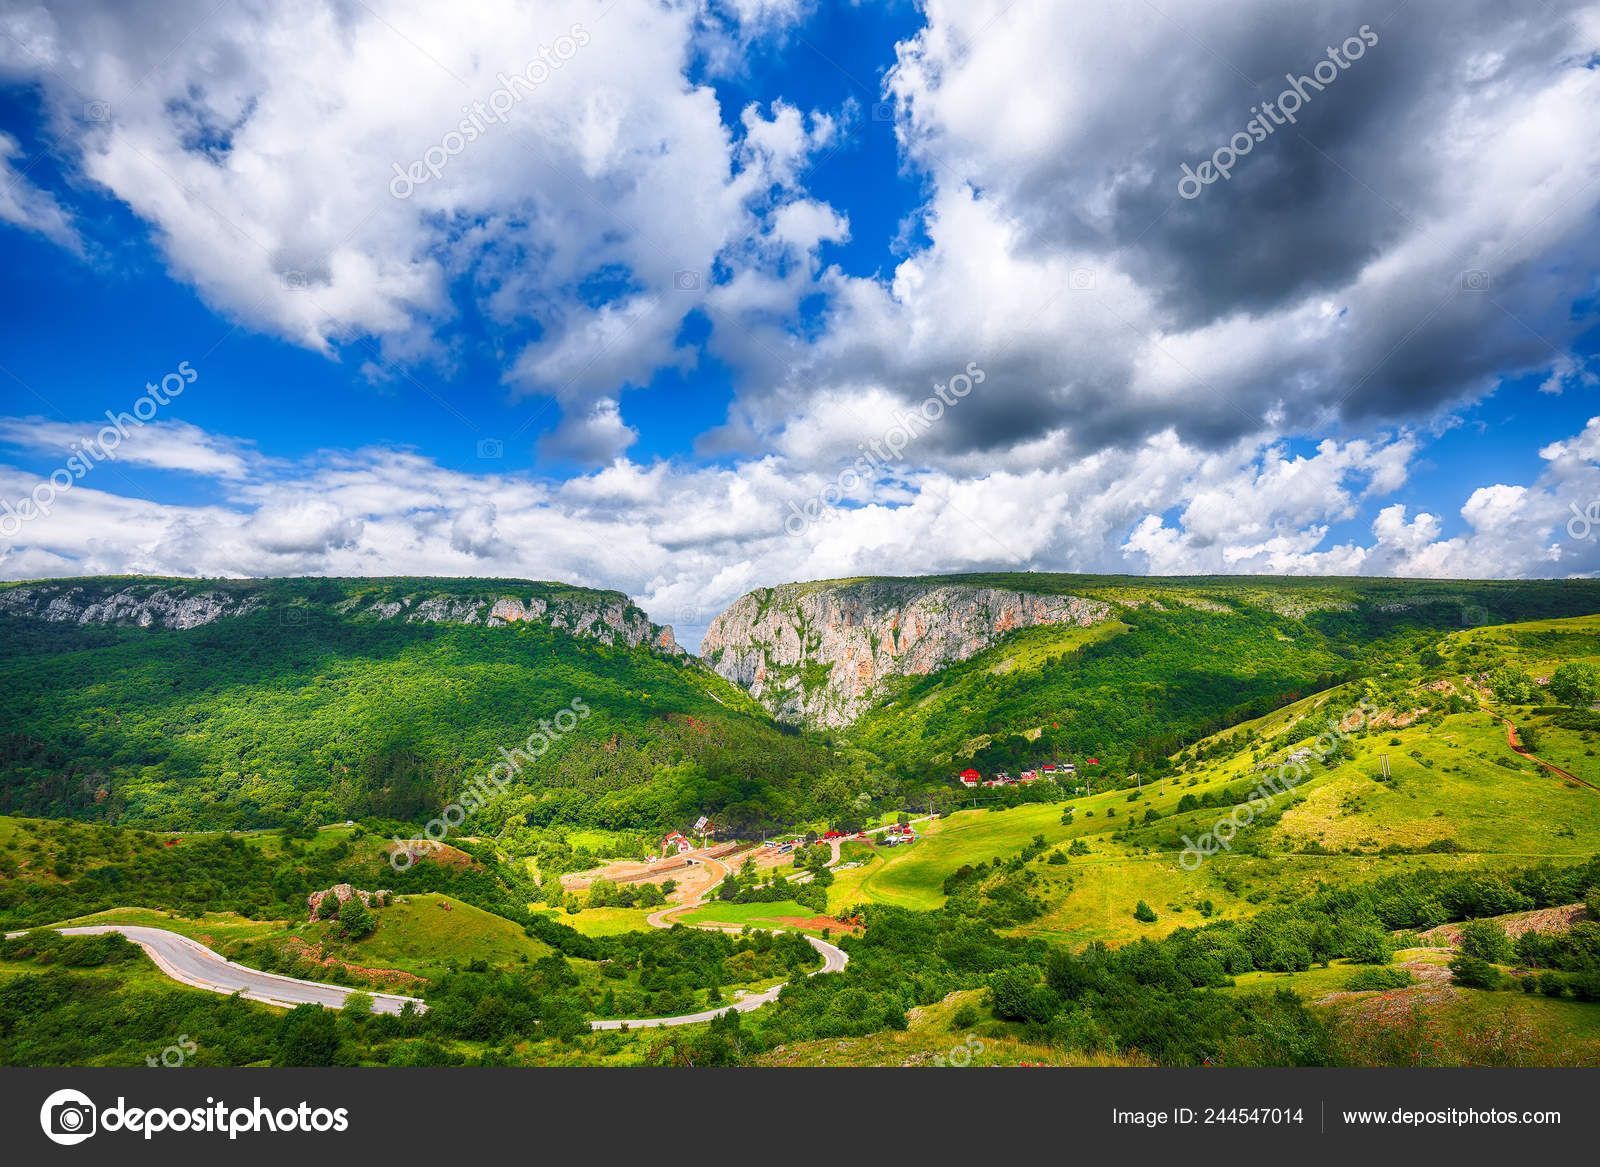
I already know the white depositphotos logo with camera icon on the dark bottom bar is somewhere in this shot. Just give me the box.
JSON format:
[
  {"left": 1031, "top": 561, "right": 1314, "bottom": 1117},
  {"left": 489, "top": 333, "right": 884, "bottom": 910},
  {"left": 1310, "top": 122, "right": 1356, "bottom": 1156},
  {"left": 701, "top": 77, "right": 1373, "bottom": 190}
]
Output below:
[{"left": 38, "top": 1090, "right": 350, "bottom": 1146}]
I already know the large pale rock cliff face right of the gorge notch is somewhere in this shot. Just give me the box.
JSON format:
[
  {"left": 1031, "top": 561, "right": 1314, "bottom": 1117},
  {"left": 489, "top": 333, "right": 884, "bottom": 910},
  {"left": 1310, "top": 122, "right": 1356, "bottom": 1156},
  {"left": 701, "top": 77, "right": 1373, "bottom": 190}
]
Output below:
[{"left": 701, "top": 579, "right": 1112, "bottom": 727}]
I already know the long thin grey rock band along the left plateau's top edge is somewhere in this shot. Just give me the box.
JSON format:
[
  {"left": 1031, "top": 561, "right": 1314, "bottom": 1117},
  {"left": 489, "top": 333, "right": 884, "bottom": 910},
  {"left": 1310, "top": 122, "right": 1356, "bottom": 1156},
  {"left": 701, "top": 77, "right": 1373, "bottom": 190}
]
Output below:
[{"left": 0, "top": 581, "right": 683, "bottom": 656}]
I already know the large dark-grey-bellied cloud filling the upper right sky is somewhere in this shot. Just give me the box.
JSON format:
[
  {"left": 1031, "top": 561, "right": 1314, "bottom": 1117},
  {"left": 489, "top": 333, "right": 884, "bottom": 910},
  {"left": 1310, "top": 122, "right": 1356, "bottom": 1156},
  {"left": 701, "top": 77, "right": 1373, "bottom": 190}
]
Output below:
[{"left": 704, "top": 0, "right": 1600, "bottom": 467}]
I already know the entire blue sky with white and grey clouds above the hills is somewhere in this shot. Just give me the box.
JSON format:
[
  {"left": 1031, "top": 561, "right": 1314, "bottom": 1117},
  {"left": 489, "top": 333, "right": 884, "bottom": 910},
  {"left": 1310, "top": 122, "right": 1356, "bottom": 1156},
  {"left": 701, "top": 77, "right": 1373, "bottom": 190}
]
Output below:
[{"left": 0, "top": 0, "right": 1600, "bottom": 647}]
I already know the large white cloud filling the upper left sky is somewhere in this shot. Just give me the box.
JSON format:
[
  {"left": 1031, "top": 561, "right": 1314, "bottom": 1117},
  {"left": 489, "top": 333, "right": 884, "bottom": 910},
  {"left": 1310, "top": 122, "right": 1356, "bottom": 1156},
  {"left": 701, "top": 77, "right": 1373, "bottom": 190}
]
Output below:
[{"left": 0, "top": 0, "right": 845, "bottom": 451}]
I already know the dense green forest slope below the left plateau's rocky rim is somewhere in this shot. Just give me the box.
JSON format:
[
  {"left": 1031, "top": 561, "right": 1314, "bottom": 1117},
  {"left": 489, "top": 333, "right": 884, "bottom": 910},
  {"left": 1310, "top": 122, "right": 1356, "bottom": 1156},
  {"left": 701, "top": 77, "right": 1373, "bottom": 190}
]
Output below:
[{"left": 0, "top": 581, "right": 866, "bottom": 834}]
